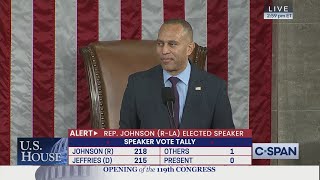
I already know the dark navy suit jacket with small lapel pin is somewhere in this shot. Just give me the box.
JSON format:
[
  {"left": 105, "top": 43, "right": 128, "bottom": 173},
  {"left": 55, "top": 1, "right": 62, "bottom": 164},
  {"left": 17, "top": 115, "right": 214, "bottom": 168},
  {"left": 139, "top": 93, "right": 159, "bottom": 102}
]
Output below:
[{"left": 120, "top": 64, "right": 234, "bottom": 129}]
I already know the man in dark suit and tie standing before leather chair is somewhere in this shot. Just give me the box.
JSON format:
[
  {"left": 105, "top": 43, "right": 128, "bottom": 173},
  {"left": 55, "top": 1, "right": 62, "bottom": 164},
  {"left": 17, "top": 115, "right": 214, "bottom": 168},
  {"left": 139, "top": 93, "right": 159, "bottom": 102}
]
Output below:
[{"left": 120, "top": 20, "right": 234, "bottom": 129}]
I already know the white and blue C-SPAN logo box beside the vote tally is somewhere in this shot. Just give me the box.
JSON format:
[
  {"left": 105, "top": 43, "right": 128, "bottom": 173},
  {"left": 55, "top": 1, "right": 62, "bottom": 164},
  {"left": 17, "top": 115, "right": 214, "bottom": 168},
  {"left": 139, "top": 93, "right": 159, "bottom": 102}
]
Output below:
[{"left": 252, "top": 143, "right": 299, "bottom": 159}]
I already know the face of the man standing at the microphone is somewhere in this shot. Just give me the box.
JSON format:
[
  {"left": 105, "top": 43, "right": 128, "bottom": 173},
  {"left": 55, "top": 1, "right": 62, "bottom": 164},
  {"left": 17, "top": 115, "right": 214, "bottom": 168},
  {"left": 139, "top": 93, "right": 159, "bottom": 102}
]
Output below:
[{"left": 157, "top": 24, "right": 194, "bottom": 75}]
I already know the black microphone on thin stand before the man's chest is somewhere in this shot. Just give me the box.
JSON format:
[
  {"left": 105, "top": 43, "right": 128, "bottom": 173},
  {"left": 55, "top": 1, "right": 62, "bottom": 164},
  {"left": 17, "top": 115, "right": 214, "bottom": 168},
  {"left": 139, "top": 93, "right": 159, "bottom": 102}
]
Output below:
[{"left": 162, "top": 87, "right": 175, "bottom": 128}]
